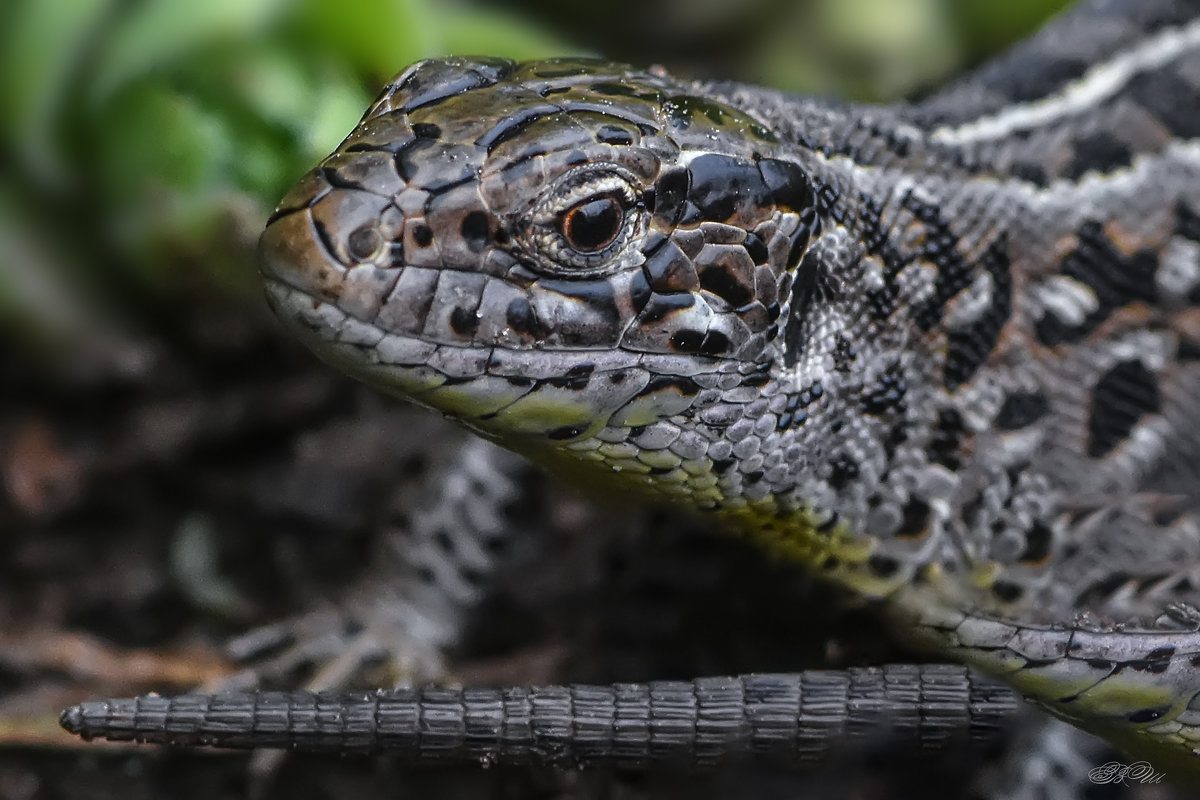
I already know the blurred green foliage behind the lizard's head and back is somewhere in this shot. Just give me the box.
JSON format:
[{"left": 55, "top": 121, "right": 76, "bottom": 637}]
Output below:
[{"left": 0, "top": 0, "right": 1068, "bottom": 368}]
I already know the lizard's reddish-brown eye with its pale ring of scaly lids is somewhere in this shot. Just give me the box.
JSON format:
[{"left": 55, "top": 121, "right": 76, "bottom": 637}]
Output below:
[{"left": 524, "top": 164, "right": 647, "bottom": 278}]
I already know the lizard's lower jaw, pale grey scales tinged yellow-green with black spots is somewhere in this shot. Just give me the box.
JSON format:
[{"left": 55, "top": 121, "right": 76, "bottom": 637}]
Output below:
[{"left": 266, "top": 278, "right": 736, "bottom": 441}]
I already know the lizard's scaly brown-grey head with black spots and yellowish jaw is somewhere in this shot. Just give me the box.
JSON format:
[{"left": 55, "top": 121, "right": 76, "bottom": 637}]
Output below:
[{"left": 260, "top": 60, "right": 873, "bottom": 537}]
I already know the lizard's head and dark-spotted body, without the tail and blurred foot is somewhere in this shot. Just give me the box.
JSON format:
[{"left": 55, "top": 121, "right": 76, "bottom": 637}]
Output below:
[{"left": 64, "top": 0, "right": 1200, "bottom": 786}]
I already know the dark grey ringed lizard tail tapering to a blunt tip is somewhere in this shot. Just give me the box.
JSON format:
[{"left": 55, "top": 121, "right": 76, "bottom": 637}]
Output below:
[{"left": 61, "top": 664, "right": 1021, "bottom": 769}]
